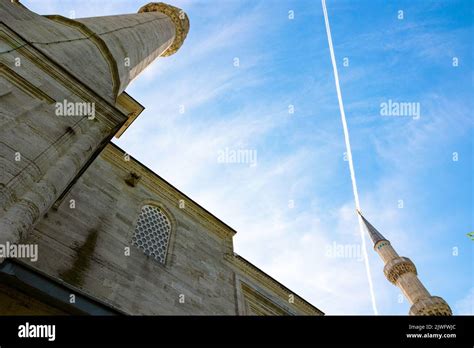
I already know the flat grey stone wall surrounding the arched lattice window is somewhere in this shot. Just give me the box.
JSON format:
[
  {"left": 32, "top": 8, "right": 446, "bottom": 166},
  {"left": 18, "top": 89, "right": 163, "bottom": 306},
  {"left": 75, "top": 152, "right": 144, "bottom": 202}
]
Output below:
[{"left": 17, "top": 145, "right": 322, "bottom": 315}]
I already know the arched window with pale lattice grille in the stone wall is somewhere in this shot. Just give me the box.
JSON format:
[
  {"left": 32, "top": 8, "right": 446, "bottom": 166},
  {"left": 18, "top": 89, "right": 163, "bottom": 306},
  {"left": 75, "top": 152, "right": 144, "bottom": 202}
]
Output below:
[{"left": 132, "top": 205, "right": 171, "bottom": 264}]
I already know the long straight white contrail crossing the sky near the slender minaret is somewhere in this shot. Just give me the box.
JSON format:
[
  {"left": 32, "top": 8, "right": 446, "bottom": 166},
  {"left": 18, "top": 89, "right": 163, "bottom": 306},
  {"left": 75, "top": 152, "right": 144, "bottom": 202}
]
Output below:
[{"left": 321, "top": 0, "right": 378, "bottom": 315}]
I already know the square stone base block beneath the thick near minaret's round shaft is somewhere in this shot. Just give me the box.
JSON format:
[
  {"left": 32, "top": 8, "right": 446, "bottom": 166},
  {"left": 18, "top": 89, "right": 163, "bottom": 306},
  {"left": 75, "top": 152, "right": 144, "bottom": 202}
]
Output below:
[{"left": 0, "top": 1, "right": 128, "bottom": 246}]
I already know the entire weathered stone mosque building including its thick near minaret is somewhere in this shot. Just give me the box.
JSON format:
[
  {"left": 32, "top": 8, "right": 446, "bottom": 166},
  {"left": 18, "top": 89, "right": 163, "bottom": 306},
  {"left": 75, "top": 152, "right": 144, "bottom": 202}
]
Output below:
[{"left": 0, "top": 0, "right": 322, "bottom": 315}]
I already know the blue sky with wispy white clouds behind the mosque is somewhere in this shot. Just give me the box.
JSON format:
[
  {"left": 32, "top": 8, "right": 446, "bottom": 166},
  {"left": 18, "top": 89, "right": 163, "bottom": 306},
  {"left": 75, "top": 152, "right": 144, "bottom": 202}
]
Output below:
[{"left": 22, "top": 0, "right": 474, "bottom": 314}]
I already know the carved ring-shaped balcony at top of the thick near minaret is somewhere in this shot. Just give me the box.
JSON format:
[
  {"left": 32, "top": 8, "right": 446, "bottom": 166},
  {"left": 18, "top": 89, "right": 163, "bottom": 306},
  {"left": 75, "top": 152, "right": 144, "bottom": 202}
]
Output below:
[{"left": 138, "top": 2, "right": 189, "bottom": 57}]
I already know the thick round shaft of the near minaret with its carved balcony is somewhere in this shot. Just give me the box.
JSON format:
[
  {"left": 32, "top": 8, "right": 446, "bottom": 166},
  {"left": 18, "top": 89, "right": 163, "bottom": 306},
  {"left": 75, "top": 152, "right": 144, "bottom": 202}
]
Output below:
[{"left": 2, "top": 3, "right": 189, "bottom": 102}]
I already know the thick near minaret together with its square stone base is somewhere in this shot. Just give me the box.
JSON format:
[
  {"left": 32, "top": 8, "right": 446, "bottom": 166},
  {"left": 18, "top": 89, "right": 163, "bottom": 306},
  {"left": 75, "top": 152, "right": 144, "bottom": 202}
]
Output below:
[{"left": 0, "top": 0, "right": 189, "bottom": 253}]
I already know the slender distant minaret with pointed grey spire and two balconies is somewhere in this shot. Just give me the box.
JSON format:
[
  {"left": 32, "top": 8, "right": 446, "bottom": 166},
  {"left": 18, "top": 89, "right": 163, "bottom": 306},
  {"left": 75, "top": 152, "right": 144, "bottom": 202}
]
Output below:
[{"left": 358, "top": 211, "right": 452, "bottom": 315}]
